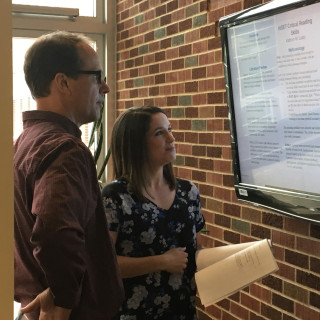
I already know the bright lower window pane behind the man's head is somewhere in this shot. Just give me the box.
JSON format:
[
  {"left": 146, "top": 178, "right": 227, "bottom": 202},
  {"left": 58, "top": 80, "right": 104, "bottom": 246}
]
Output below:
[{"left": 12, "top": 37, "right": 96, "bottom": 148}]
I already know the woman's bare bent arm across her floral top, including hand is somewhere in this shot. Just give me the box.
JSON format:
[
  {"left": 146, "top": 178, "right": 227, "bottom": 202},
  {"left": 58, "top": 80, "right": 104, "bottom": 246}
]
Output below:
[{"left": 110, "top": 231, "right": 188, "bottom": 278}]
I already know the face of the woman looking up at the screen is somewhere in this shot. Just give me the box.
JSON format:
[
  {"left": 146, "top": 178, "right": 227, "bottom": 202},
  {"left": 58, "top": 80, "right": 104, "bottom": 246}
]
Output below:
[{"left": 147, "top": 112, "right": 176, "bottom": 167}]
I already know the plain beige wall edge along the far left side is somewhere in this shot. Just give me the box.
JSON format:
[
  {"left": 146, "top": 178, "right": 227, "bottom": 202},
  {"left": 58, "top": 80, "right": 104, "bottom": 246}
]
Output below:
[{"left": 0, "top": 0, "right": 13, "bottom": 320}]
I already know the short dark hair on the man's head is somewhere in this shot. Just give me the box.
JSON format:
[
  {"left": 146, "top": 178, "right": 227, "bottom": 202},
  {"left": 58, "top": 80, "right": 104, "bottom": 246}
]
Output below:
[{"left": 24, "top": 31, "right": 90, "bottom": 98}]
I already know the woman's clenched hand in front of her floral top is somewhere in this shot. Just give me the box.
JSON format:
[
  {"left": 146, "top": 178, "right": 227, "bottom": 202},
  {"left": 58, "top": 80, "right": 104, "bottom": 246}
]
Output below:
[{"left": 162, "top": 248, "right": 188, "bottom": 273}]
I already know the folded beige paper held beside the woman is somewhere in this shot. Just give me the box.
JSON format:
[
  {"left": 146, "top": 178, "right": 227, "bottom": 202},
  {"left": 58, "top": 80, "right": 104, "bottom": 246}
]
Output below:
[{"left": 195, "top": 239, "right": 278, "bottom": 307}]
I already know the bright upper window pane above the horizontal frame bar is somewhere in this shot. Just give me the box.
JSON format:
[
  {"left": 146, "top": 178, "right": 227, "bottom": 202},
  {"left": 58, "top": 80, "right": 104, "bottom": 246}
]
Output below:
[{"left": 12, "top": 0, "right": 96, "bottom": 17}]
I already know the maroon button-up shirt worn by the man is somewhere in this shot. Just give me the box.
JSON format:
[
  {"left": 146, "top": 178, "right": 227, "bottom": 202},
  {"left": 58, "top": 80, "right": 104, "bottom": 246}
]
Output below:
[{"left": 14, "top": 111, "right": 123, "bottom": 320}]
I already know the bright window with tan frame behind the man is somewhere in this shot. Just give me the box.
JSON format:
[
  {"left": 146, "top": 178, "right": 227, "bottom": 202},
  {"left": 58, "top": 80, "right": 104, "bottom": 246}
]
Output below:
[{"left": 12, "top": 0, "right": 116, "bottom": 316}]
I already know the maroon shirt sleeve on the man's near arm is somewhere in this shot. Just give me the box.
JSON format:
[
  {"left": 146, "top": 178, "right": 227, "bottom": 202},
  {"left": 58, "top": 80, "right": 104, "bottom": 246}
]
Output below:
[{"left": 31, "top": 141, "right": 97, "bottom": 309}]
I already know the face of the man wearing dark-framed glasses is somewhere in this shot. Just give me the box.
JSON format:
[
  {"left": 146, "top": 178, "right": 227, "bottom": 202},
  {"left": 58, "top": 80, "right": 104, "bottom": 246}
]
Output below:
[{"left": 70, "top": 43, "right": 110, "bottom": 126}]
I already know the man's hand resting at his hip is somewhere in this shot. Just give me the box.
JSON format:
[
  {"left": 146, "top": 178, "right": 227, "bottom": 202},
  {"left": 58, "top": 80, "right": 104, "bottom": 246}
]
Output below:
[{"left": 21, "top": 288, "right": 71, "bottom": 320}]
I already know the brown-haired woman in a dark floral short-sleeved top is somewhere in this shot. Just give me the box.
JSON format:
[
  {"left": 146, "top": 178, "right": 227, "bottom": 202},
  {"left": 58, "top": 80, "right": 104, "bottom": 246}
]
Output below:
[{"left": 102, "top": 107, "right": 204, "bottom": 320}]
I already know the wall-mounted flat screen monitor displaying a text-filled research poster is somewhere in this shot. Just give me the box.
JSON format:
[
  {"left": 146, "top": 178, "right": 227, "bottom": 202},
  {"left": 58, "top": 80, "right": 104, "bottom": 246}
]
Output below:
[{"left": 219, "top": 0, "right": 320, "bottom": 224}]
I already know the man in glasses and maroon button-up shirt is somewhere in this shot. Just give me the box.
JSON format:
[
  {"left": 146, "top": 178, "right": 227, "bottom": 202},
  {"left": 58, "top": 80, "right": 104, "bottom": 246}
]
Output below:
[{"left": 14, "top": 31, "right": 123, "bottom": 320}]
